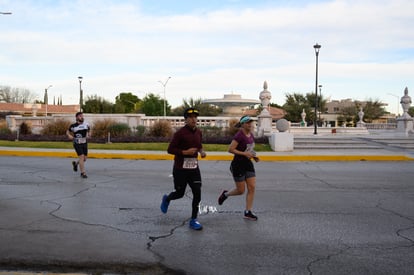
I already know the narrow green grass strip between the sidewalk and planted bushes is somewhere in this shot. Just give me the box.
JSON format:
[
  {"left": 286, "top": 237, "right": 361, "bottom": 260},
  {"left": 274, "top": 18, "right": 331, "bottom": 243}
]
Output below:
[{"left": 0, "top": 140, "right": 271, "bottom": 152}]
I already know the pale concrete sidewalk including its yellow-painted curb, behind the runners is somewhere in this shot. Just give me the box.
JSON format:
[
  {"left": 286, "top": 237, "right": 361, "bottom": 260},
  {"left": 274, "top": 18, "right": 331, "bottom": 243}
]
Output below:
[{"left": 0, "top": 146, "right": 414, "bottom": 161}]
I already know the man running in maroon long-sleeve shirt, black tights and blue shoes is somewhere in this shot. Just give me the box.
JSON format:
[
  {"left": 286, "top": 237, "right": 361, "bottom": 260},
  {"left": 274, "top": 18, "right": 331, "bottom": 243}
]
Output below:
[{"left": 161, "top": 108, "right": 206, "bottom": 230}]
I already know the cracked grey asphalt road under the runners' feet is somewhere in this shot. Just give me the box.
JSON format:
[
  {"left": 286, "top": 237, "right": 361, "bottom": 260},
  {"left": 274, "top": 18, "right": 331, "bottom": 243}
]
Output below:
[{"left": 0, "top": 156, "right": 414, "bottom": 275}]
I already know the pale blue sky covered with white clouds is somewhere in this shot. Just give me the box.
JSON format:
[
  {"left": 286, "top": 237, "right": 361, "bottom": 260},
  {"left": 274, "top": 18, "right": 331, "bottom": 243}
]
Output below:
[{"left": 0, "top": 0, "right": 414, "bottom": 112}]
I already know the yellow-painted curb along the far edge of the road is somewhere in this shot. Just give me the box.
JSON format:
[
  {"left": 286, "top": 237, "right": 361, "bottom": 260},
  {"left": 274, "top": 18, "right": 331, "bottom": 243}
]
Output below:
[{"left": 0, "top": 150, "right": 414, "bottom": 162}]
